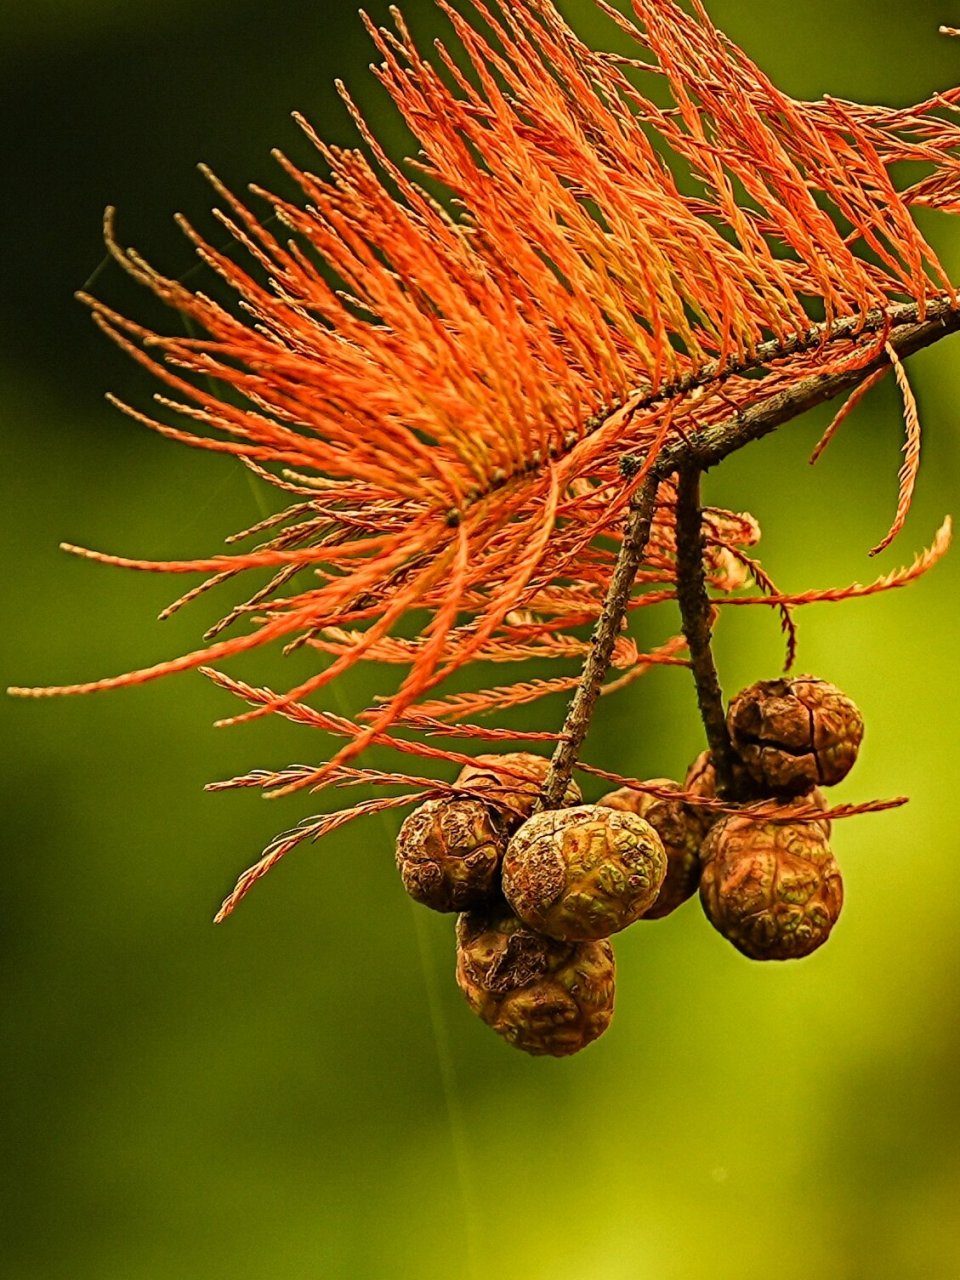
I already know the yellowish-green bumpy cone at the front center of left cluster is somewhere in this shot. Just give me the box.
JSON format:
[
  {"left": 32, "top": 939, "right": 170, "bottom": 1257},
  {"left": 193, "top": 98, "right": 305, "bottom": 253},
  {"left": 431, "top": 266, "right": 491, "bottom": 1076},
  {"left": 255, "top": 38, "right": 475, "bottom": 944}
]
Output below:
[{"left": 503, "top": 805, "right": 667, "bottom": 940}]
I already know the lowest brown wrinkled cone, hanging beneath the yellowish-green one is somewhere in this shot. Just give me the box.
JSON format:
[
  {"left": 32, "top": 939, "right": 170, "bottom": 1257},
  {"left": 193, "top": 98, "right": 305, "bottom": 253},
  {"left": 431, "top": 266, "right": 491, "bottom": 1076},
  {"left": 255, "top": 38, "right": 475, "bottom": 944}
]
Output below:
[{"left": 457, "top": 908, "right": 614, "bottom": 1057}]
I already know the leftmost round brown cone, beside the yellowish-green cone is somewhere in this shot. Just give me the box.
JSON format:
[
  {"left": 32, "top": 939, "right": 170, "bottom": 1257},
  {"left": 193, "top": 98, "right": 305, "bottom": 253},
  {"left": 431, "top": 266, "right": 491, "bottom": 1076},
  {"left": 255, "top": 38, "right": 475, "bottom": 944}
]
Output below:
[{"left": 397, "top": 796, "right": 507, "bottom": 911}]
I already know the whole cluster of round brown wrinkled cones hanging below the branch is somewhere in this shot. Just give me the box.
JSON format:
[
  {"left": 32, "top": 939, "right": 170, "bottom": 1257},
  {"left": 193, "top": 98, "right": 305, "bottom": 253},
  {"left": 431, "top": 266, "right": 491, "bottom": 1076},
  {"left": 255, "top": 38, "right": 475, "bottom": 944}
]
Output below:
[{"left": 397, "top": 676, "right": 863, "bottom": 1057}]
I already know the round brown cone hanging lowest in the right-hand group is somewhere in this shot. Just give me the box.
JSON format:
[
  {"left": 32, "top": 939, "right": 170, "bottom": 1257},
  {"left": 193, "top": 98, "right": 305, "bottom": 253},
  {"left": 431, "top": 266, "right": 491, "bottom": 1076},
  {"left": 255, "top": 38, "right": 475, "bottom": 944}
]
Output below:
[{"left": 700, "top": 815, "right": 844, "bottom": 960}]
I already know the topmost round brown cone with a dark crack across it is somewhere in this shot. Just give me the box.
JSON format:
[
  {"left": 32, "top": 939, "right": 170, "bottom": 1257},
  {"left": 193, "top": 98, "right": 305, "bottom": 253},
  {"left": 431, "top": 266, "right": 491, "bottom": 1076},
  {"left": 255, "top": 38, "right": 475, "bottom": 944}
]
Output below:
[{"left": 727, "top": 676, "right": 863, "bottom": 795}]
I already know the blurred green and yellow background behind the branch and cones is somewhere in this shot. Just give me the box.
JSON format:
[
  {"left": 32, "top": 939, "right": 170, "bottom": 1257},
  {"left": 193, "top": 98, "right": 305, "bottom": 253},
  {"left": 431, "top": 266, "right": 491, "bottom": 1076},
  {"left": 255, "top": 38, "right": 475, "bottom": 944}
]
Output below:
[{"left": 0, "top": 0, "right": 960, "bottom": 1280}]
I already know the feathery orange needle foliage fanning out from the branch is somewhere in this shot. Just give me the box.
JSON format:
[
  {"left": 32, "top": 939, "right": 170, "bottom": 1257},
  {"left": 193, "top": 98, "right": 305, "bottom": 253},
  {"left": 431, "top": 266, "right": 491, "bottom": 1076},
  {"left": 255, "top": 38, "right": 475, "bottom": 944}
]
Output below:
[{"left": 9, "top": 0, "right": 960, "bottom": 921}]
